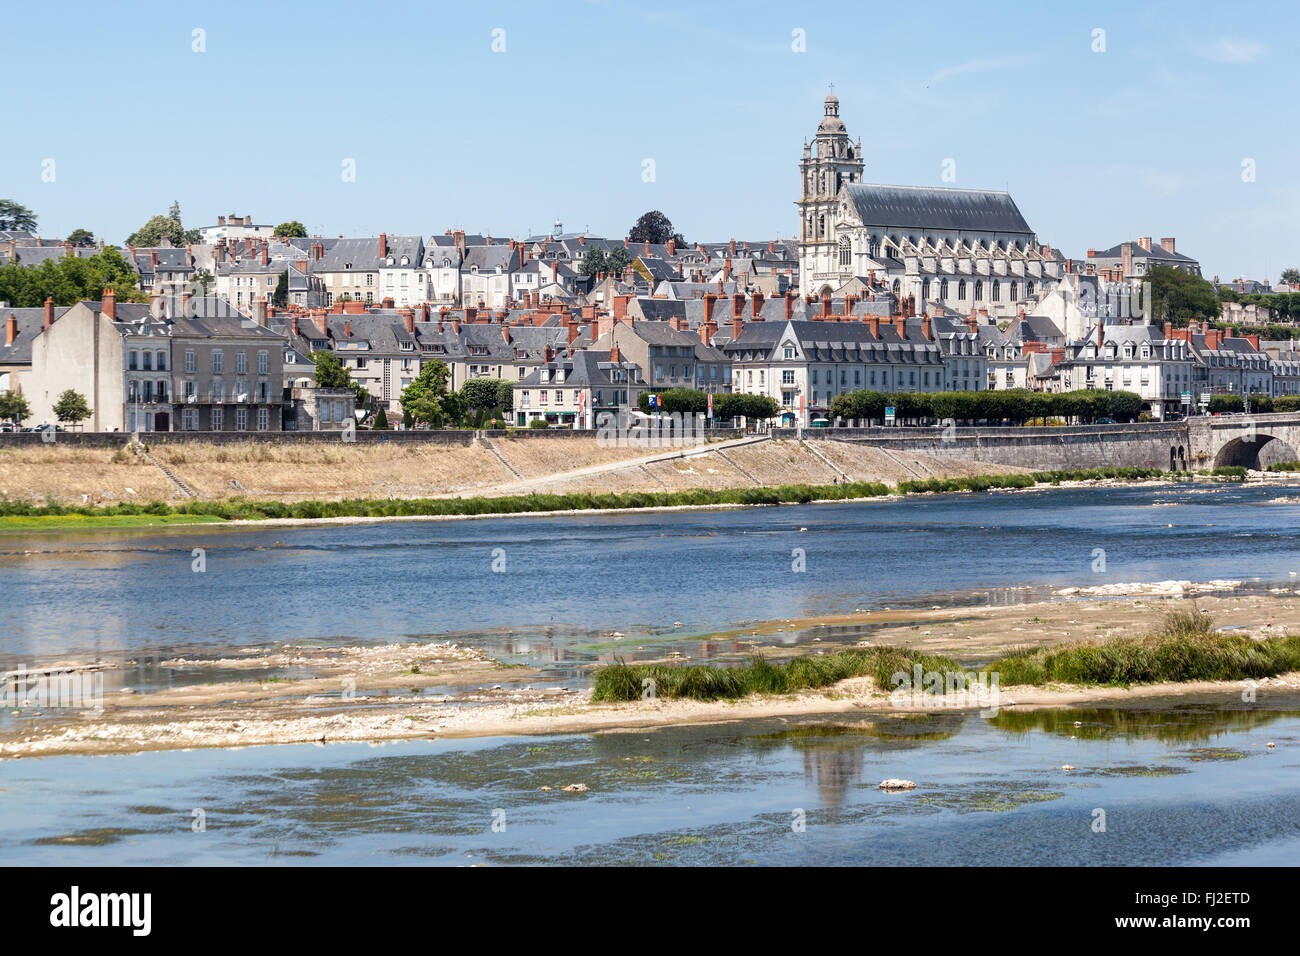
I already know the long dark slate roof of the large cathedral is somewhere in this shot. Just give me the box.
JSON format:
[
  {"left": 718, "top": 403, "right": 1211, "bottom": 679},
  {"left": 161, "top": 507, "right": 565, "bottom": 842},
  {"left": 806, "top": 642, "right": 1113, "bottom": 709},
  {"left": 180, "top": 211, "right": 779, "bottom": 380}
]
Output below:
[{"left": 845, "top": 182, "right": 1034, "bottom": 235}]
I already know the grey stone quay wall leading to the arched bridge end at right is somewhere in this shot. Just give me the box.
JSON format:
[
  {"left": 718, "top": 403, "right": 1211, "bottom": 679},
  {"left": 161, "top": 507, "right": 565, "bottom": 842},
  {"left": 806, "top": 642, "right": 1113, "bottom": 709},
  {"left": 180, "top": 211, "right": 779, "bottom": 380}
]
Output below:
[{"left": 772, "top": 414, "right": 1300, "bottom": 471}]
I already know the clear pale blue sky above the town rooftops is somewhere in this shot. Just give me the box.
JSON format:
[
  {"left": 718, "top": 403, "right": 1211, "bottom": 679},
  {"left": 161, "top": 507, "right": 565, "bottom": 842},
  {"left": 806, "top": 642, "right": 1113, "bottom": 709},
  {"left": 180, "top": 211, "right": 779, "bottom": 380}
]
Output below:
[{"left": 0, "top": 0, "right": 1300, "bottom": 281}]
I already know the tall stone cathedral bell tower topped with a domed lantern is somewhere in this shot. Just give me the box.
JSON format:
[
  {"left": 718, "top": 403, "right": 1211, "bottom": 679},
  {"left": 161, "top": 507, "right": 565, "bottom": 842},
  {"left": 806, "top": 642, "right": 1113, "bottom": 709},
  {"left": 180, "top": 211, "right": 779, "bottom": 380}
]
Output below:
[{"left": 796, "top": 94, "right": 862, "bottom": 295}]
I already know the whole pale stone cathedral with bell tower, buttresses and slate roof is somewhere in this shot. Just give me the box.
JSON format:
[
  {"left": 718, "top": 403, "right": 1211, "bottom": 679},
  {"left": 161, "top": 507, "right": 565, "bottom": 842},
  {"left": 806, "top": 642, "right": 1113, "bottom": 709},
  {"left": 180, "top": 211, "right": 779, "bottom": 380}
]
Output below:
[{"left": 797, "top": 95, "right": 1065, "bottom": 320}]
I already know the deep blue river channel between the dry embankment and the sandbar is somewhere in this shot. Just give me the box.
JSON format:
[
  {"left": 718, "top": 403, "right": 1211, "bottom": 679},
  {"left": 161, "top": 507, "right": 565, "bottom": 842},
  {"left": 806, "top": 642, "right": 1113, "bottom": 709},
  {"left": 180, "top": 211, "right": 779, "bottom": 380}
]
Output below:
[{"left": 0, "top": 485, "right": 1300, "bottom": 666}]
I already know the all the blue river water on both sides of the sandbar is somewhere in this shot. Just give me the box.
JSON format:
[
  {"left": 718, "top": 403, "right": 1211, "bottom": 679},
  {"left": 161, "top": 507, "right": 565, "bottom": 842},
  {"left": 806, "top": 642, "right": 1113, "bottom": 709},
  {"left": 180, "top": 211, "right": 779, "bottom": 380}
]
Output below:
[{"left": 0, "top": 485, "right": 1300, "bottom": 865}]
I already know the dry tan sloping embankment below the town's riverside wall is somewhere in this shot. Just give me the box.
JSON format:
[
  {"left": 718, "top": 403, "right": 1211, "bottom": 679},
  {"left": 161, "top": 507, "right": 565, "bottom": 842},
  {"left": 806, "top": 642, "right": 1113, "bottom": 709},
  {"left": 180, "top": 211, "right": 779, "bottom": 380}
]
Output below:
[{"left": 0, "top": 437, "right": 1022, "bottom": 503}]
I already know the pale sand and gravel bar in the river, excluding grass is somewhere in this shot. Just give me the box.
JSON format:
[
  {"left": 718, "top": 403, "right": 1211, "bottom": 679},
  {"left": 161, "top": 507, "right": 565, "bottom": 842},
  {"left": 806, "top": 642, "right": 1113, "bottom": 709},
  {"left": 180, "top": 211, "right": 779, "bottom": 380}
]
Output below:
[{"left": 0, "top": 581, "right": 1300, "bottom": 758}]
